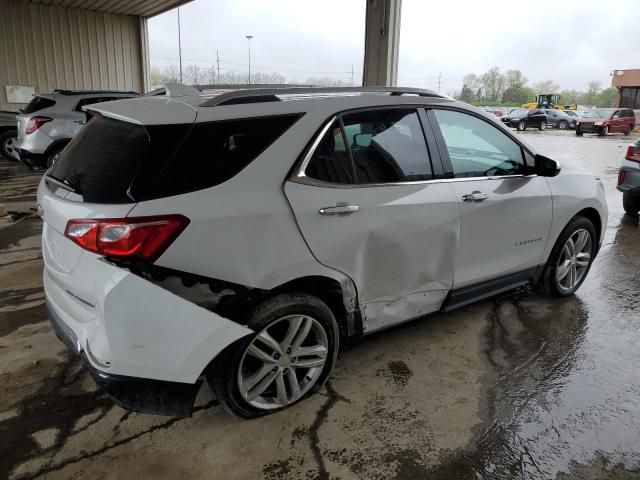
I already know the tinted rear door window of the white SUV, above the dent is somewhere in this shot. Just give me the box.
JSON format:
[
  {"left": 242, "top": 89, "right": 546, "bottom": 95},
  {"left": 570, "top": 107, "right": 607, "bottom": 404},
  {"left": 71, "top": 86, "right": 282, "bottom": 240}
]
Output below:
[{"left": 342, "top": 109, "right": 433, "bottom": 184}]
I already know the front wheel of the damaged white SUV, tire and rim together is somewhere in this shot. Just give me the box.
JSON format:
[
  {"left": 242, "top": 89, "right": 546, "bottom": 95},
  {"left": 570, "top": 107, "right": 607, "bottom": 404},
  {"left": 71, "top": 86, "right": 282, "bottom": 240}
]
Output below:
[{"left": 540, "top": 216, "right": 598, "bottom": 297}]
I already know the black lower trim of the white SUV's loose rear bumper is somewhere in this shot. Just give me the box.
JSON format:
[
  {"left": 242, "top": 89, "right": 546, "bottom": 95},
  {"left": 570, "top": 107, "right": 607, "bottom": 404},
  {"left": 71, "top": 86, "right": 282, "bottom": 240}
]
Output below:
[{"left": 47, "top": 301, "right": 201, "bottom": 417}]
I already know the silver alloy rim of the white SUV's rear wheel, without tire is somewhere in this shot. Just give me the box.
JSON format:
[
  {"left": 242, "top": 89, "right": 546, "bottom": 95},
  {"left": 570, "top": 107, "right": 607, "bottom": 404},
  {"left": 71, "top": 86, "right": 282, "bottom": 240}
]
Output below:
[{"left": 237, "top": 315, "right": 329, "bottom": 410}]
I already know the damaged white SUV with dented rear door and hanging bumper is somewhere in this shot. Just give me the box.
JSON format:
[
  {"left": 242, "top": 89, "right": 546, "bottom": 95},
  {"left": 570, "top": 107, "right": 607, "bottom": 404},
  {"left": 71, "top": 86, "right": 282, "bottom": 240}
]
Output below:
[{"left": 38, "top": 88, "right": 607, "bottom": 417}]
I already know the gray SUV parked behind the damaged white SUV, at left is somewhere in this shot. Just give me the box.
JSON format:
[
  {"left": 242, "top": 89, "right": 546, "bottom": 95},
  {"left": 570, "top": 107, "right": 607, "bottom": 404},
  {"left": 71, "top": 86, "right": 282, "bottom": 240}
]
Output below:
[{"left": 16, "top": 90, "right": 139, "bottom": 167}]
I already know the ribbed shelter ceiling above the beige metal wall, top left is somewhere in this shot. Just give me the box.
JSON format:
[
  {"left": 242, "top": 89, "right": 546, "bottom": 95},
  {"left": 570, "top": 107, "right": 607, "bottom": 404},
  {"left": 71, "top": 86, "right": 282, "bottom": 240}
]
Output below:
[{"left": 20, "top": 0, "right": 192, "bottom": 17}]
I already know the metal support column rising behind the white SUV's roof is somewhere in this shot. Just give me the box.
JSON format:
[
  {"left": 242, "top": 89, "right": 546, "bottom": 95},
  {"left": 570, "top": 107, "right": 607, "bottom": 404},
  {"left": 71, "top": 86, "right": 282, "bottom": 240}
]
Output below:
[{"left": 362, "top": 0, "right": 402, "bottom": 87}]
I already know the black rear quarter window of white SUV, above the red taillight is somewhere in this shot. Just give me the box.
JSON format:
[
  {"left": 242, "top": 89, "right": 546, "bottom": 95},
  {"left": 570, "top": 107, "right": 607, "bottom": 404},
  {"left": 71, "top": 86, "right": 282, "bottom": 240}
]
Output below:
[{"left": 144, "top": 114, "right": 301, "bottom": 199}]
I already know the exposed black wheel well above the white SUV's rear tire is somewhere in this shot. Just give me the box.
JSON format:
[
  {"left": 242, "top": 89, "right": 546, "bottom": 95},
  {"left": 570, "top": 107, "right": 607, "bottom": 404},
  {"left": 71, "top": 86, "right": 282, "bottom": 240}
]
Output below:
[{"left": 271, "top": 276, "right": 362, "bottom": 338}]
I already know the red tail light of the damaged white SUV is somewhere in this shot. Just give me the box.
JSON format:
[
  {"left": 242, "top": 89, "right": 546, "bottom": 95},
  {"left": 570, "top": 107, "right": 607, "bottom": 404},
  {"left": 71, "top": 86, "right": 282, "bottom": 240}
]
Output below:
[{"left": 64, "top": 215, "right": 189, "bottom": 262}]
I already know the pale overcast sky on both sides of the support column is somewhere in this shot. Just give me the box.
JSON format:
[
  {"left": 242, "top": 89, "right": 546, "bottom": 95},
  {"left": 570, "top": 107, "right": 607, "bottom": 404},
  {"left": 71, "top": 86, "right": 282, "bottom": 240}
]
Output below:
[{"left": 149, "top": 0, "right": 640, "bottom": 92}]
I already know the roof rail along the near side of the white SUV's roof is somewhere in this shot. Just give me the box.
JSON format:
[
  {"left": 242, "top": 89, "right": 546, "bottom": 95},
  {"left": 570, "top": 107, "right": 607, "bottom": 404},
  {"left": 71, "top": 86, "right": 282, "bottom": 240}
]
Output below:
[{"left": 200, "top": 87, "right": 446, "bottom": 107}]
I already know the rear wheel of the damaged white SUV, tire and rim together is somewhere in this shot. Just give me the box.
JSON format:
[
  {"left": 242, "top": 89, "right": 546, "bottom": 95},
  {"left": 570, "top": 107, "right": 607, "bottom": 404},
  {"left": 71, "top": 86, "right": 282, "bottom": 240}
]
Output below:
[{"left": 206, "top": 293, "right": 339, "bottom": 418}]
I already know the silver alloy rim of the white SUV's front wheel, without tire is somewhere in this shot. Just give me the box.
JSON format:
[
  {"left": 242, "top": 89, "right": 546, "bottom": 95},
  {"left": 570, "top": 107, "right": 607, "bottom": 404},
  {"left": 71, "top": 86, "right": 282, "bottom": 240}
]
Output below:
[{"left": 556, "top": 228, "right": 592, "bottom": 291}]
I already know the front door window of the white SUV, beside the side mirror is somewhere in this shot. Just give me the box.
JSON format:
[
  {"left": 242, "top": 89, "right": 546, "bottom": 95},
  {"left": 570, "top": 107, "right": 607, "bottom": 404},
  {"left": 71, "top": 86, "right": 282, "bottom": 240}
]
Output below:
[{"left": 433, "top": 110, "right": 526, "bottom": 178}]
